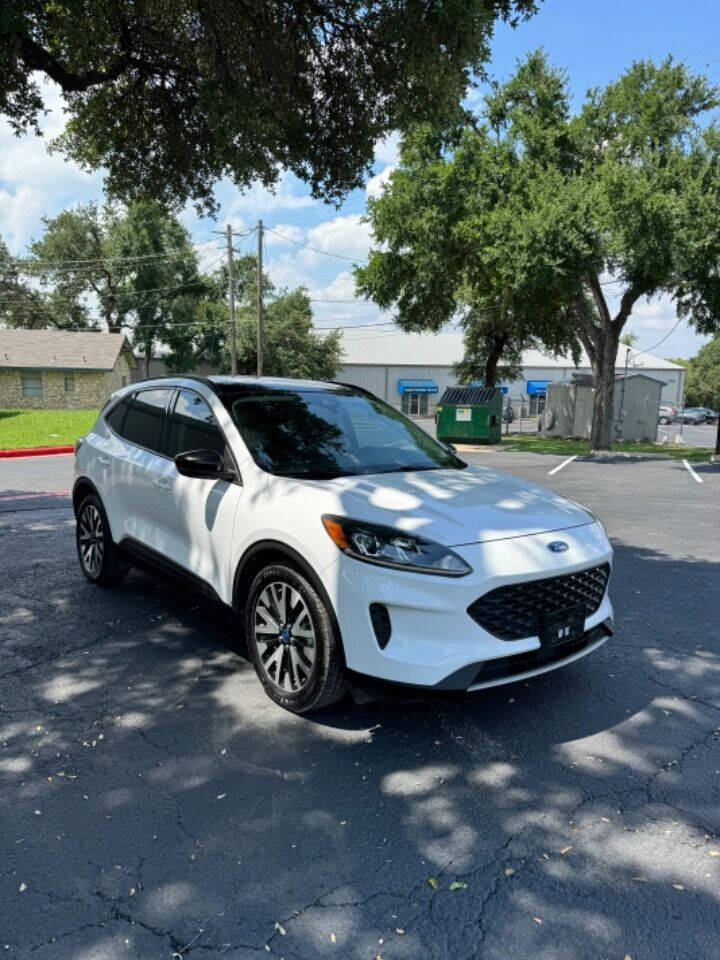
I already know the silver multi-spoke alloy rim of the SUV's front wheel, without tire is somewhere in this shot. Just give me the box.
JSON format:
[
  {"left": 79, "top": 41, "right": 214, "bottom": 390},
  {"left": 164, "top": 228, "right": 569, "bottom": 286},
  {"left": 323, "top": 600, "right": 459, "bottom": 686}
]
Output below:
[{"left": 253, "top": 581, "right": 317, "bottom": 693}]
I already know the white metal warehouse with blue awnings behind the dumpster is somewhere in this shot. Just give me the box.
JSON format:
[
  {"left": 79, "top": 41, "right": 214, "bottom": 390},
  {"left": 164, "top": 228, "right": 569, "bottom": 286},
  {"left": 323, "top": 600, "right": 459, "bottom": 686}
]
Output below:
[{"left": 336, "top": 328, "right": 685, "bottom": 416}]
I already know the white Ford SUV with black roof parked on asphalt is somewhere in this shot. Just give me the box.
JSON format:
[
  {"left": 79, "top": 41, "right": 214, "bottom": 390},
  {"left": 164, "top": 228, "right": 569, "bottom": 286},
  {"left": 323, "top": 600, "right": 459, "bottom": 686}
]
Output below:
[{"left": 73, "top": 376, "right": 612, "bottom": 712}]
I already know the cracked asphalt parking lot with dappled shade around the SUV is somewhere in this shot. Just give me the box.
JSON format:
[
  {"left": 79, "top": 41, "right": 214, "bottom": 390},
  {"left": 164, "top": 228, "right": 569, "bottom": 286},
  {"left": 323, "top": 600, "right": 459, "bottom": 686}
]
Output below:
[{"left": 0, "top": 452, "right": 720, "bottom": 960}]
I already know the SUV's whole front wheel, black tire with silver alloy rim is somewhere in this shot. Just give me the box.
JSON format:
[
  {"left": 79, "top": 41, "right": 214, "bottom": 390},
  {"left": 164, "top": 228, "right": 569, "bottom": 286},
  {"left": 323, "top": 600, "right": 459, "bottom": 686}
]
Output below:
[{"left": 245, "top": 563, "right": 347, "bottom": 713}]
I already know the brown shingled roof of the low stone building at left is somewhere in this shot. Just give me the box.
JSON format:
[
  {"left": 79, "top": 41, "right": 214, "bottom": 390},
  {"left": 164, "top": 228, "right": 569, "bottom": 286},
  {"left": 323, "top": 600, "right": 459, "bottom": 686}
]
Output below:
[{"left": 0, "top": 330, "right": 137, "bottom": 370}]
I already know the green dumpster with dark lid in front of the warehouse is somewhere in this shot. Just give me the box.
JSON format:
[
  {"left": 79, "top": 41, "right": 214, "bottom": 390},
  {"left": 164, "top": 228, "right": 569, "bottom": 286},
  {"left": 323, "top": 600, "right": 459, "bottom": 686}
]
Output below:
[{"left": 436, "top": 387, "right": 502, "bottom": 443}]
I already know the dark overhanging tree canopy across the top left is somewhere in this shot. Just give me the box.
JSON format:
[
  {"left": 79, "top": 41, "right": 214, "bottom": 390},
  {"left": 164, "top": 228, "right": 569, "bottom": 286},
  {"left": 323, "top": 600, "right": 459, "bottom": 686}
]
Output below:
[{"left": 0, "top": 0, "right": 536, "bottom": 206}]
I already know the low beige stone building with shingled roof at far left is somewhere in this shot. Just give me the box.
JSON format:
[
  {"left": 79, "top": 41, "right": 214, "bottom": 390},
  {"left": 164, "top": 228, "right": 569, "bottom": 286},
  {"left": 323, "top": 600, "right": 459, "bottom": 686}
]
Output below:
[{"left": 0, "top": 330, "right": 137, "bottom": 410}]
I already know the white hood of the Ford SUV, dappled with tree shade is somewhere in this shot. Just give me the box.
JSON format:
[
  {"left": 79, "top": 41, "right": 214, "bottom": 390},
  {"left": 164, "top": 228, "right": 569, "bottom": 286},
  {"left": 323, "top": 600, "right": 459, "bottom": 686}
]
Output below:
[{"left": 274, "top": 466, "right": 594, "bottom": 547}]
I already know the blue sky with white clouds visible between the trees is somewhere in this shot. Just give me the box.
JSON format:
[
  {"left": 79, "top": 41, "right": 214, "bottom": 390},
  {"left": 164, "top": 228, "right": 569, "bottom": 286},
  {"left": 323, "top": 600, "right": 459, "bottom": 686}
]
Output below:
[{"left": 0, "top": 0, "right": 720, "bottom": 356}]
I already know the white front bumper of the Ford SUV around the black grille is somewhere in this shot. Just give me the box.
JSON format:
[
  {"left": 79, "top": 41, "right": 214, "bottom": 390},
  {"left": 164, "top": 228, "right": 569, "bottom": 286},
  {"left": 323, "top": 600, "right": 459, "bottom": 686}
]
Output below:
[{"left": 323, "top": 523, "right": 613, "bottom": 690}]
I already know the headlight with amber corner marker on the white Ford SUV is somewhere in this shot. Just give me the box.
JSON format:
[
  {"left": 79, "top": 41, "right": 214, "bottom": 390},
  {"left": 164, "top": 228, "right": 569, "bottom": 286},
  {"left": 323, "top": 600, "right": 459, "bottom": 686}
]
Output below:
[{"left": 322, "top": 514, "right": 472, "bottom": 577}]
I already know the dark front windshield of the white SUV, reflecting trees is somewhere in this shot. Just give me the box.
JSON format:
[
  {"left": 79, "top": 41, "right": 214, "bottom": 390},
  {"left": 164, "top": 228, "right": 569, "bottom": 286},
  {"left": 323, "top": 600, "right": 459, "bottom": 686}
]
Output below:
[{"left": 223, "top": 389, "right": 466, "bottom": 479}]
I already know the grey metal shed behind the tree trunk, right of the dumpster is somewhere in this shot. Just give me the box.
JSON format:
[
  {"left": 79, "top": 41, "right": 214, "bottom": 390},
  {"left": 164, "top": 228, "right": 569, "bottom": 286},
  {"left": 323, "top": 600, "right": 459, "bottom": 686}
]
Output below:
[{"left": 541, "top": 373, "right": 665, "bottom": 441}]
